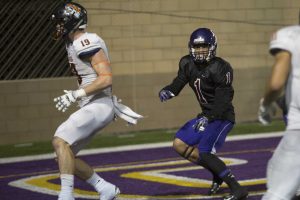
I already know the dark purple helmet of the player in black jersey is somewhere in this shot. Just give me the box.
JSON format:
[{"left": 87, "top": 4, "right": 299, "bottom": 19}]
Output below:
[{"left": 188, "top": 28, "right": 217, "bottom": 63}]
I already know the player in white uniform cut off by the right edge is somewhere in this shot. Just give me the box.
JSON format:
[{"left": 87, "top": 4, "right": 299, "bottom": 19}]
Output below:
[{"left": 258, "top": 26, "right": 300, "bottom": 200}]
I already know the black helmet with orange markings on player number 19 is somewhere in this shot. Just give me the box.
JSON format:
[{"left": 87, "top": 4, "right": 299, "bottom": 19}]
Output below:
[{"left": 51, "top": 2, "right": 87, "bottom": 40}]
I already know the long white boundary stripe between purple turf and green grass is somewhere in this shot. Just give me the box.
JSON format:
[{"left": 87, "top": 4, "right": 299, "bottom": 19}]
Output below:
[{"left": 0, "top": 131, "right": 283, "bottom": 164}]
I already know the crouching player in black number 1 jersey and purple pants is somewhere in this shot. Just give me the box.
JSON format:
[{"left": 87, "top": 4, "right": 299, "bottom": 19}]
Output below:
[{"left": 159, "top": 28, "right": 248, "bottom": 200}]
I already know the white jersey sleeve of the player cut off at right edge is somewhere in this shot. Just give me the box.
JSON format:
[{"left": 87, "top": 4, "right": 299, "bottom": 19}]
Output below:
[{"left": 269, "top": 27, "right": 297, "bottom": 54}]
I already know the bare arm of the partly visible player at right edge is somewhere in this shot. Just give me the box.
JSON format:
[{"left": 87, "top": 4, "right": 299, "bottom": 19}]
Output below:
[{"left": 262, "top": 50, "right": 291, "bottom": 107}]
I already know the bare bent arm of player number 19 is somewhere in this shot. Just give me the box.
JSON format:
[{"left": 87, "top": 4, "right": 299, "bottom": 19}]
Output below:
[{"left": 84, "top": 49, "right": 112, "bottom": 96}]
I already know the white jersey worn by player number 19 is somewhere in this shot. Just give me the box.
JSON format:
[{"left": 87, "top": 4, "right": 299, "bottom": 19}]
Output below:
[{"left": 66, "top": 33, "right": 112, "bottom": 107}]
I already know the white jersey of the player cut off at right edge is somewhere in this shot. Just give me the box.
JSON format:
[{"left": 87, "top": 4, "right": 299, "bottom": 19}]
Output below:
[{"left": 270, "top": 26, "right": 300, "bottom": 130}]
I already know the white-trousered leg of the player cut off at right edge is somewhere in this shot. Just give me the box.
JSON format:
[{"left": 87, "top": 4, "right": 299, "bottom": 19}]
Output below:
[{"left": 263, "top": 130, "right": 300, "bottom": 200}]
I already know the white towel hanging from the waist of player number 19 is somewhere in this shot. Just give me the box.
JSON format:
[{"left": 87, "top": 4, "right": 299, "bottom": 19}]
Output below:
[{"left": 112, "top": 96, "right": 144, "bottom": 124}]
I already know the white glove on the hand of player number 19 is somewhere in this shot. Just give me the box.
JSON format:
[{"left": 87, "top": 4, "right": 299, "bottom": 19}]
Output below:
[{"left": 54, "top": 89, "right": 86, "bottom": 112}]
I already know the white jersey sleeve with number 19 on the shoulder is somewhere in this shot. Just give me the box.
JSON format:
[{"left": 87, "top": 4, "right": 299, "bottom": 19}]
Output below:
[{"left": 73, "top": 34, "right": 103, "bottom": 58}]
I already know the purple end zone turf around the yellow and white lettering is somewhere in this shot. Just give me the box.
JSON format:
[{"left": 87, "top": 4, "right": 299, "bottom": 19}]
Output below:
[{"left": 0, "top": 137, "right": 280, "bottom": 200}]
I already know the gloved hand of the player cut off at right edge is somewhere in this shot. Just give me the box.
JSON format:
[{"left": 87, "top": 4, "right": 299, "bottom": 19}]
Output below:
[{"left": 258, "top": 99, "right": 276, "bottom": 125}]
